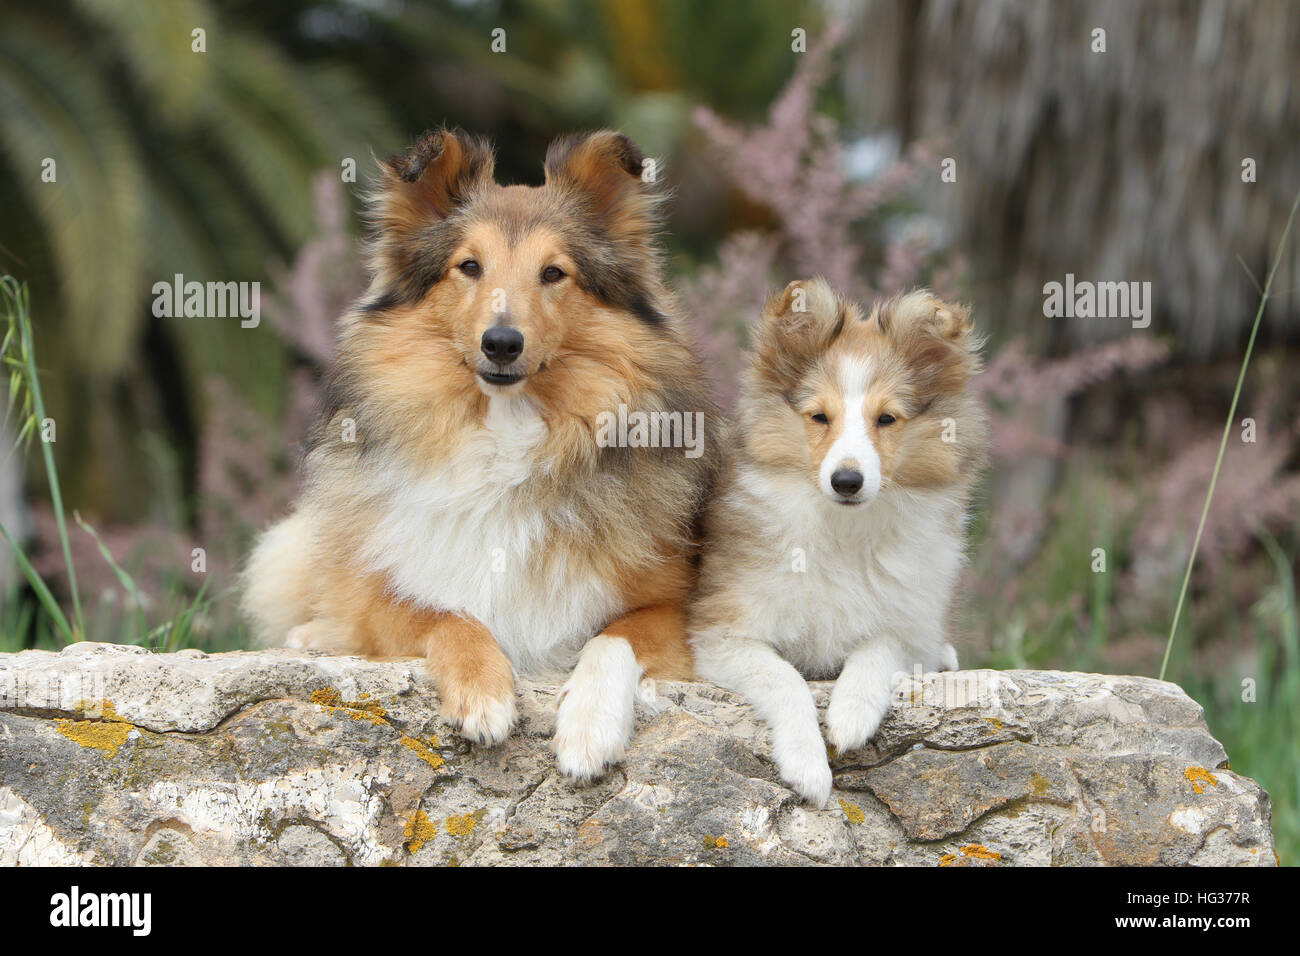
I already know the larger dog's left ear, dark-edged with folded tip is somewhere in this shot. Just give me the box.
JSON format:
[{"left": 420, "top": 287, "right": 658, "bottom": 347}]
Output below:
[{"left": 376, "top": 129, "right": 495, "bottom": 228}]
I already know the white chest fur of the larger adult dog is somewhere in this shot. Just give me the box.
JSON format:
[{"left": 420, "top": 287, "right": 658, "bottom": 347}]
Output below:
[{"left": 363, "top": 395, "right": 619, "bottom": 674}]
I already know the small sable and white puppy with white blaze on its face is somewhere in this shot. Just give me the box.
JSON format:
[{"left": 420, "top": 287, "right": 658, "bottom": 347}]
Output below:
[{"left": 689, "top": 278, "right": 987, "bottom": 806}]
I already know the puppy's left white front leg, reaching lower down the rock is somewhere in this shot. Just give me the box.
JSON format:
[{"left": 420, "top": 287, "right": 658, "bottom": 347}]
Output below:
[{"left": 694, "top": 633, "right": 833, "bottom": 806}]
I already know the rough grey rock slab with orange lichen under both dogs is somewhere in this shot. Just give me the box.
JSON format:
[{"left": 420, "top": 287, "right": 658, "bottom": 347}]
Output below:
[{"left": 0, "top": 644, "right": 1275, "bottom": 866}]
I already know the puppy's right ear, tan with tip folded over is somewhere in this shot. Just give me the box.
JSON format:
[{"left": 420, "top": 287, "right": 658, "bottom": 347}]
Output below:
[{"left": 874, "top": 291, "right": 983, "bottom": 395}]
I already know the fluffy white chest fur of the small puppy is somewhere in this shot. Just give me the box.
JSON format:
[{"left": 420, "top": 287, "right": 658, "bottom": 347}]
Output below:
[{"left": 732, "top": 475, "right": 963, "bottom": 678}]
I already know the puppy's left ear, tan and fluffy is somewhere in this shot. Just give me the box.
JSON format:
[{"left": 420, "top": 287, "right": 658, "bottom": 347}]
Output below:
[{"left": 757, "top": 276, "right": 857, "bottom": 389}]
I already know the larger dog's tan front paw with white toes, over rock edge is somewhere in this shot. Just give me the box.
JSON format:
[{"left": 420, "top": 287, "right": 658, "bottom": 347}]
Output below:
[{"left": 426, "top": 614, "right": 516, "bottom": 745}]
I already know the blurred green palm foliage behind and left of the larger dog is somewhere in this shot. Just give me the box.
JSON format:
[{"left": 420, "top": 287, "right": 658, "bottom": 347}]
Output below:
[{"left": 0, "top": 0, "right": 811, "bottom": 520}]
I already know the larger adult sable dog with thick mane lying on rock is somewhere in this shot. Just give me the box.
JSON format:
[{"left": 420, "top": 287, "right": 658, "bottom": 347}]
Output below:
[{"left": 244, "top": 130, "right": 715, "bottom": 778}]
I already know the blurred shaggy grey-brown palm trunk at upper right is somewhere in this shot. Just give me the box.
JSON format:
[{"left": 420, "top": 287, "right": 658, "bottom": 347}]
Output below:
[{"left": 845, "top": 0, "right": 1300, "bottom": 359}]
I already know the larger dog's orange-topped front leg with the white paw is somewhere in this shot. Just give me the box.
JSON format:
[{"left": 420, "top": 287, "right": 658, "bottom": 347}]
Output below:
[{"left": 555, "top": 605, "right": 692, "bottom": 780}]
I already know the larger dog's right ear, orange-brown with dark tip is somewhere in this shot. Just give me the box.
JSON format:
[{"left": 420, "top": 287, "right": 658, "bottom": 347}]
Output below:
[{"left": 546, "top": 130, "right": 658, "bottom": 238}]
